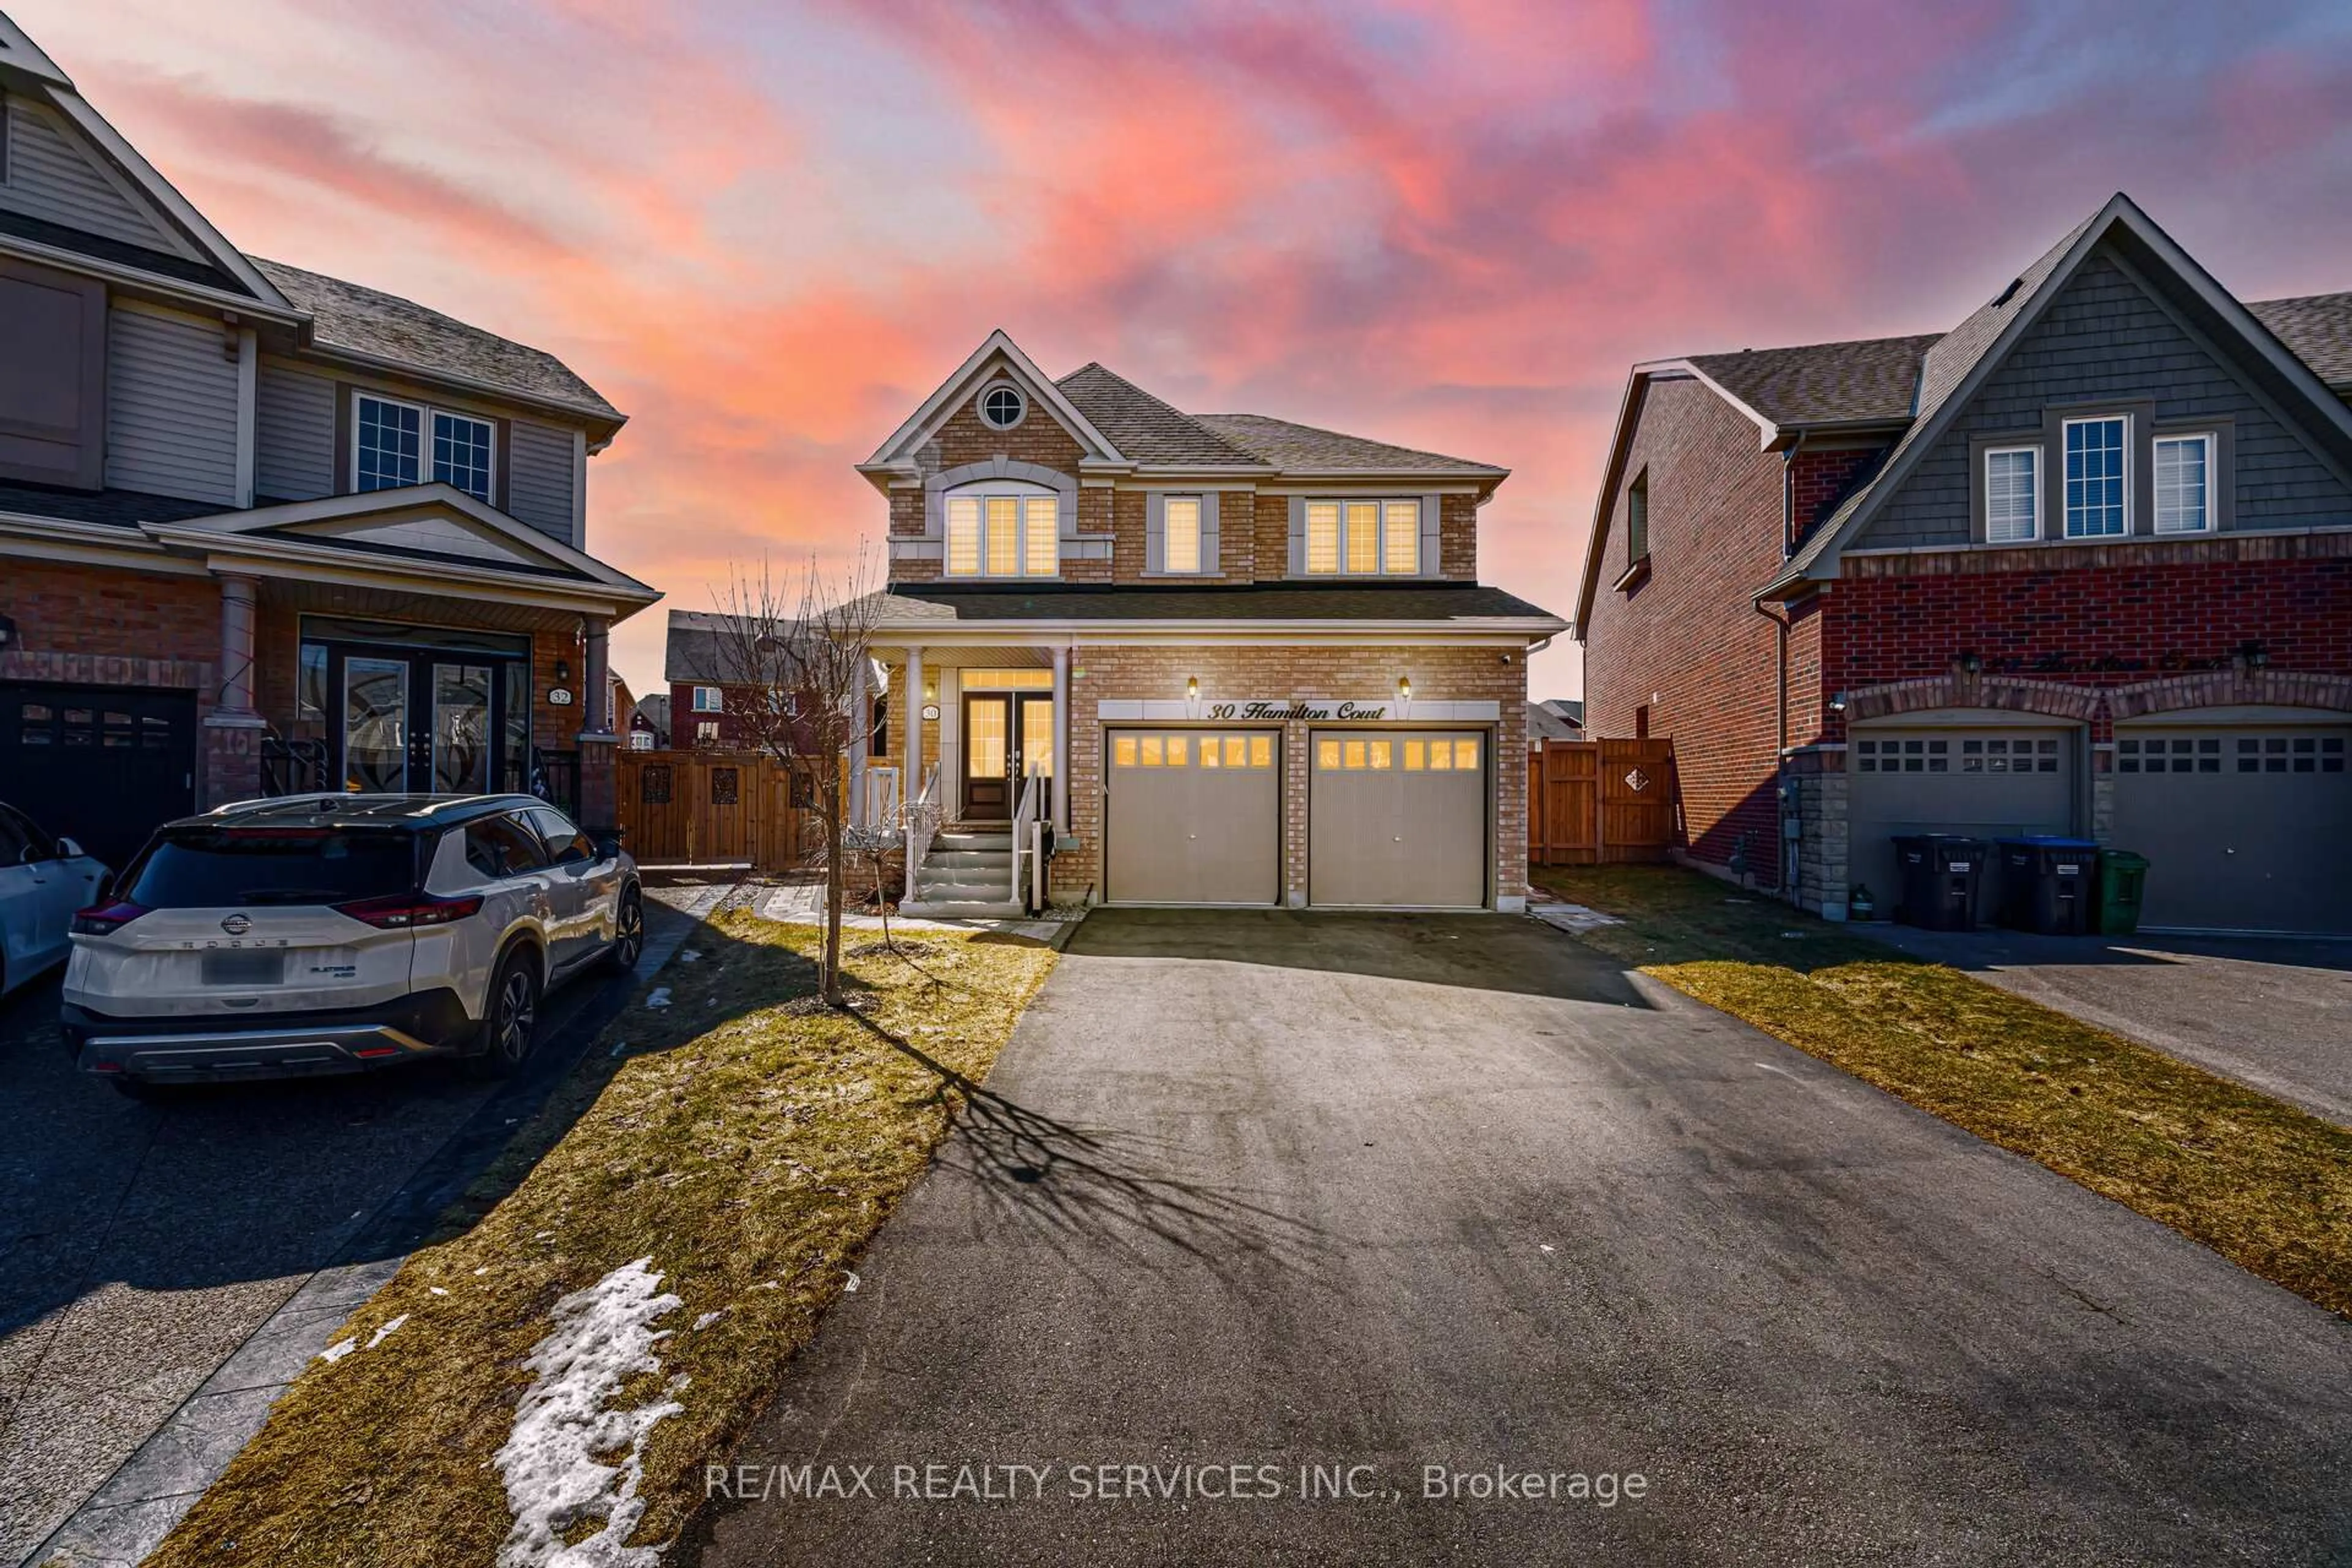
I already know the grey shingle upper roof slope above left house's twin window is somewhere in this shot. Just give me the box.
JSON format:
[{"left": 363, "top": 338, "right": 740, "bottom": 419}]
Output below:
[{"left": 252, "top": 256, "right": 624, "bottom": 426}]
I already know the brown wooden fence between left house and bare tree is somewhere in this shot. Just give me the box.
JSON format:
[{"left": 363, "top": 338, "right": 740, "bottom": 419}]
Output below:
[{"left": 616, "top": 752, "right": 816, "bottom": 872}]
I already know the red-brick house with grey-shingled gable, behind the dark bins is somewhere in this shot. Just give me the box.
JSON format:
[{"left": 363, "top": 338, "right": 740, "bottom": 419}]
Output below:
[{"left": 1576, "top": 195, "right": 2352, "bottom": 931}]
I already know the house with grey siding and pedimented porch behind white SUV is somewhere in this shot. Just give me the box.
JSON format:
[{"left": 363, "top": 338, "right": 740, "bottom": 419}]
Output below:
[{"left": 0, "top": 17, "right": 658, "bottom": 861}]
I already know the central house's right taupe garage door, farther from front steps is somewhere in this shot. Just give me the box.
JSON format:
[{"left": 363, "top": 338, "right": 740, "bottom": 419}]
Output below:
[{"left": 1308, "top": 731, "right": 1487, "bottom": 910}]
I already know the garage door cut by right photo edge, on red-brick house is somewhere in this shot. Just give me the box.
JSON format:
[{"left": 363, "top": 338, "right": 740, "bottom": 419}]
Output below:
[{"left": 2114, "top": 724, "right": 2352, "bottom": 933}]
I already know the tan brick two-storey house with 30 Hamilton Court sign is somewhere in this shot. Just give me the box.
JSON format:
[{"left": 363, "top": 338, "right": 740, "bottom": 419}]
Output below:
[{"left": 837, "top": 331, "right": 1566, "bottom": 910}]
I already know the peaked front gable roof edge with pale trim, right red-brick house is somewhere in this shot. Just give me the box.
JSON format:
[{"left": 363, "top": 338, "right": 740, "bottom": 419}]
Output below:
[{"left": 1759, "top": 190, "right": 2352, "bottom": 597}]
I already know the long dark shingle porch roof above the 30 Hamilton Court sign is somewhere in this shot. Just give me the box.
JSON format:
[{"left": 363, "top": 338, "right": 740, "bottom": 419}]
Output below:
[{"left": 875, "top": 583, "right": 1550, "bottom": 625}]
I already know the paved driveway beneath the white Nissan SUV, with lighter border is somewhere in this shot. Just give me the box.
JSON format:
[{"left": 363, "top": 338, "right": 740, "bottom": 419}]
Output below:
[{"left": 0, "top": 891, "right": 698, "bottom": 1563}]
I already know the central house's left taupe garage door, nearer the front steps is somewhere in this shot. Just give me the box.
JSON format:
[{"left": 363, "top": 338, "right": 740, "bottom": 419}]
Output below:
[{"left": 1103, "top": 729, "right": 1282, "bottom": 905}]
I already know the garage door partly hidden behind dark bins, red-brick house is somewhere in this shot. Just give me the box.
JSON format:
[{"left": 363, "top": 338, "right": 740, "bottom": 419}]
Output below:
[{"left": 1846, "top": 726, "right": 2077, "bottom": 912}]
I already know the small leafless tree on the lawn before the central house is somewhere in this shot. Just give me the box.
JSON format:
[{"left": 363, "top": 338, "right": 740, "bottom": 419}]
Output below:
[{"left": 717, "top": 548, "right": 882, "bottom": 1006}]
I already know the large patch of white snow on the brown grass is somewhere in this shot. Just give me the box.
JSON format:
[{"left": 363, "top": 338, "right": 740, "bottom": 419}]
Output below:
[{"left": 492, "top": 1257, "right": 684, "bottom": 1568}]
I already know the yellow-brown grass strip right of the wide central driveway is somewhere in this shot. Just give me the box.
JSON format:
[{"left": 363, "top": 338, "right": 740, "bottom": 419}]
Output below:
[{"left": 1538, "top": 867, "right": 2352, "bottom": 1316}]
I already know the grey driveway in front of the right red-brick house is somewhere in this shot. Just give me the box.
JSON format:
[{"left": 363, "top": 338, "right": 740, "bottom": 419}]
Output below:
[{"left": 1872, "top": 926, "right": 2352, "bottom": 1126}]
